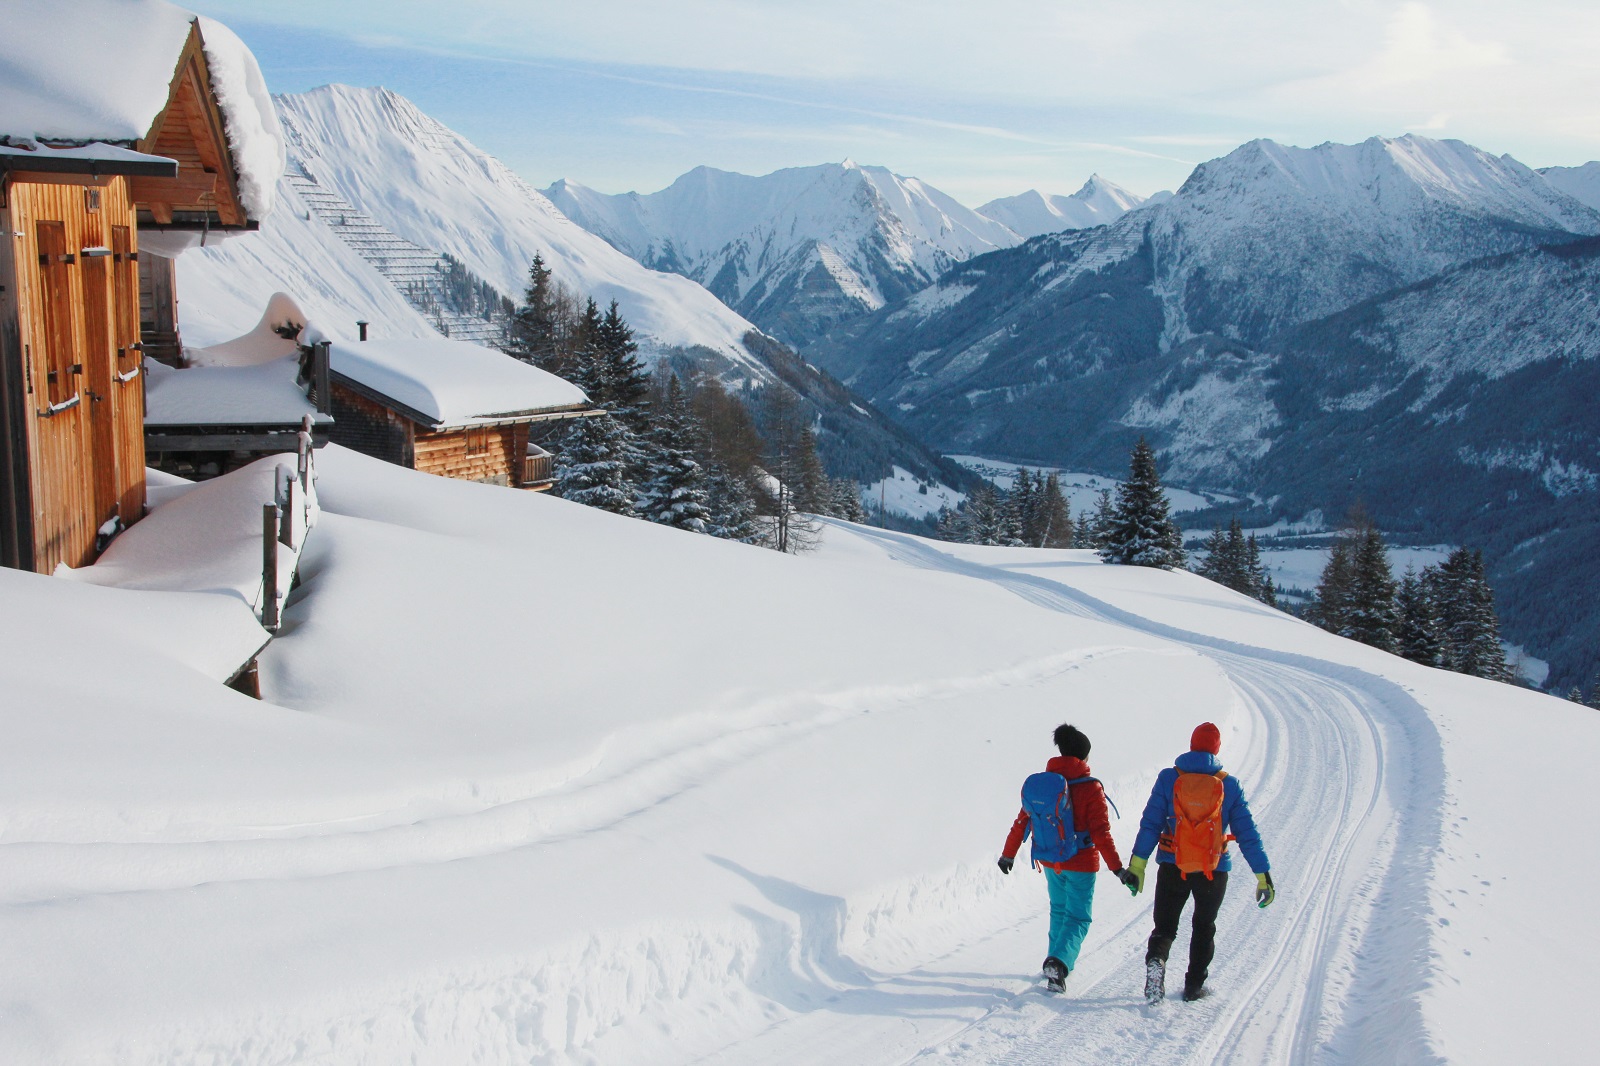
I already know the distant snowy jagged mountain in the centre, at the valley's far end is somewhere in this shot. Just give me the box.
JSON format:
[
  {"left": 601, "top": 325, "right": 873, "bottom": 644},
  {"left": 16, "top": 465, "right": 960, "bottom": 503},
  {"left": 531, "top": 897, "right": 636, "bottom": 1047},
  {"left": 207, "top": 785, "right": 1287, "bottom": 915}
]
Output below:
[{"left": 546, "top": 160, "right": 1018, "bottom": 344}]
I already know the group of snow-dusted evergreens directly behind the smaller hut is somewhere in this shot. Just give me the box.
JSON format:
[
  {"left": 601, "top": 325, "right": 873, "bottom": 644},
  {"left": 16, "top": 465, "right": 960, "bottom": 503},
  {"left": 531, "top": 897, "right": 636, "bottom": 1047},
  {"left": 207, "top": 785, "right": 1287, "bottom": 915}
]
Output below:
[{"left": 506, "top": 254, "right": 866, "bottom": 552}]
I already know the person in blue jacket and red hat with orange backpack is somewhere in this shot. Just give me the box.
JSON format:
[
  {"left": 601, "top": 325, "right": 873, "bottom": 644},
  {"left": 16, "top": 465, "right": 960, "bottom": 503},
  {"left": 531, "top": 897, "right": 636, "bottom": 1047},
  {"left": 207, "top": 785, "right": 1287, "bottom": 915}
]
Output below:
[{"left": 1128, "top": 722, "right": 1277, "bottom": 1002}]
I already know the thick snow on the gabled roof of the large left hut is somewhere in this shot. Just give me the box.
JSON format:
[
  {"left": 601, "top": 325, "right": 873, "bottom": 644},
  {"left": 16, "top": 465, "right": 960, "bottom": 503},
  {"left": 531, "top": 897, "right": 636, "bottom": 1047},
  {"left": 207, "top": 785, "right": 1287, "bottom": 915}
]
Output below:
[{"left": 0, "top": 0, "right": 285, "bottom": 219}]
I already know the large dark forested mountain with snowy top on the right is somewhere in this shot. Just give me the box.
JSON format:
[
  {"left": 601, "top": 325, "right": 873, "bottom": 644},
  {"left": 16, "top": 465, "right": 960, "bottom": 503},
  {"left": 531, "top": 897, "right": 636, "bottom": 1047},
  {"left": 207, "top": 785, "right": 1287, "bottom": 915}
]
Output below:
[{"left": 806, "top": 136, "right": 1600, "bottom": 683}]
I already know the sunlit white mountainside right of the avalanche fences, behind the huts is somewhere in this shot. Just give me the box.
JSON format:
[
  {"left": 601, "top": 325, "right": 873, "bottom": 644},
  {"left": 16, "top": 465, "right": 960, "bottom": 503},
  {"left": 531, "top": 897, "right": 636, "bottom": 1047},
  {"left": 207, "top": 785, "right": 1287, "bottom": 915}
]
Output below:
[{"left": 275, "top": 85, "right": 754, "bottom": 365}]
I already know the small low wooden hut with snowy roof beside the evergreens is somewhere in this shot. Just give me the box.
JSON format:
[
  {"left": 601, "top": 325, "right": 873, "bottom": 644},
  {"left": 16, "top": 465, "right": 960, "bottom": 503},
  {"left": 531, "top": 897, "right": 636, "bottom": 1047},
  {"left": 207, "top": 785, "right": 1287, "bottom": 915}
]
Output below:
[{"left": 328, "top": 338, "right": 590, "bottom": 490}]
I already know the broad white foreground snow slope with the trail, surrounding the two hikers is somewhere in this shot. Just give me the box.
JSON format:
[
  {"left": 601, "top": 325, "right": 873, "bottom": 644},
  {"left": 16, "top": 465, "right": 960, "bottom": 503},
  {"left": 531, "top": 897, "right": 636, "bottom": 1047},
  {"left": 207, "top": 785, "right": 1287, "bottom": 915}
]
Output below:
[{"left": 0, "top": 448, "right": 1600, "bottom": 1064}]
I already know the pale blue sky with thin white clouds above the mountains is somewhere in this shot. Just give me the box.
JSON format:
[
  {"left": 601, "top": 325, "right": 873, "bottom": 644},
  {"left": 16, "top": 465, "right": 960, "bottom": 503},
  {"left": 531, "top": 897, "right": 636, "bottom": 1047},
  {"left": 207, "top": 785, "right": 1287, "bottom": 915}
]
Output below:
[{"left": 194, "top": 0, "right": 1600, "bottom": 205}]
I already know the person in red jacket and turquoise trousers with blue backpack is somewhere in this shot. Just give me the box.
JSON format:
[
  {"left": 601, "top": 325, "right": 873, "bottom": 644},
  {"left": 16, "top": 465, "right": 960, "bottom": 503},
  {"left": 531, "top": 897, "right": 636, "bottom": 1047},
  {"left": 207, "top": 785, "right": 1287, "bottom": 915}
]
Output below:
[{"left": 1000, "top": 725, "right": 1134, "bottom": 992}]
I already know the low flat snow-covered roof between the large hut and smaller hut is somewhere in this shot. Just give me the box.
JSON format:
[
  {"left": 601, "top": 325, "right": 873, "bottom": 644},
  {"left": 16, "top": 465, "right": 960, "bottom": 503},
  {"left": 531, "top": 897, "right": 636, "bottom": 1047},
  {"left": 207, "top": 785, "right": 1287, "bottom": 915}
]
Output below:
[{"left": 144, "top": 355, "right": 330, "bottom": 426}]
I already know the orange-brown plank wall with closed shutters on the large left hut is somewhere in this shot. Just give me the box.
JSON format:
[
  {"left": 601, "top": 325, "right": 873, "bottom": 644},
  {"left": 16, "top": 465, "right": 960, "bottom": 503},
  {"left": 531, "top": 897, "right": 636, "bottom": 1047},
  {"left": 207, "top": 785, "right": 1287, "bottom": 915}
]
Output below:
[{"left": 5, "top": 173, "right": 144, "bottom": 573}]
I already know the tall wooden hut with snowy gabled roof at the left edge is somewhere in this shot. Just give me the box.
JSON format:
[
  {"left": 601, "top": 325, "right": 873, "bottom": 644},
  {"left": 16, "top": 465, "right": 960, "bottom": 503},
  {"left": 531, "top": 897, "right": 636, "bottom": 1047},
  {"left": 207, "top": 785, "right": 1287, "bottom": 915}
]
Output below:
[{"left": 0, "top": 0, "right": 283, "bottom": 571}]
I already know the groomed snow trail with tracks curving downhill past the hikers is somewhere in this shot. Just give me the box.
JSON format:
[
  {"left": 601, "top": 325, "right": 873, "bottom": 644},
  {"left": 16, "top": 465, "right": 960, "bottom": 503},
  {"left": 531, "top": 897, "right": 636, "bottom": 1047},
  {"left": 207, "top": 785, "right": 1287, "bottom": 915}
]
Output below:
[{"left": 800, "top": 527, "right": 1443, "bottom": 1064}]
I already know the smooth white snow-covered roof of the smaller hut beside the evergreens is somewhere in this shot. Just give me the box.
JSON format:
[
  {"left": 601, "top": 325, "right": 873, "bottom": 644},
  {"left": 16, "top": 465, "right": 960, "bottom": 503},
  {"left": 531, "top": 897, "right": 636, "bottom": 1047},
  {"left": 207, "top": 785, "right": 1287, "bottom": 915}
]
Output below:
[{"left": 321, "top": 331, "right": 589, "bottom": 426}]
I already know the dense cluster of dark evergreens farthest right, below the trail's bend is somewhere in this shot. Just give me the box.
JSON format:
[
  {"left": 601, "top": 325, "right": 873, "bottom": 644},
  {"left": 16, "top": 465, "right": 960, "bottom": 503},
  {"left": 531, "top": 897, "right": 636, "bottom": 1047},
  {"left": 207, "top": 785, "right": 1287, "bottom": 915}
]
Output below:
[{"left": 1309, "top": 511, "right": 1514, "bottom": 682}]
